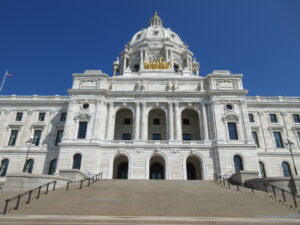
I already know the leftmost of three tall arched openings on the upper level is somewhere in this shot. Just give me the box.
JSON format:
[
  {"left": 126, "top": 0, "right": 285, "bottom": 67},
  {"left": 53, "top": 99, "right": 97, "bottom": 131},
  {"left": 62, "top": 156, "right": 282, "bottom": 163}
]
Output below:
[{"left": 114, "top": 109, "right": 133, "bottom": 140}]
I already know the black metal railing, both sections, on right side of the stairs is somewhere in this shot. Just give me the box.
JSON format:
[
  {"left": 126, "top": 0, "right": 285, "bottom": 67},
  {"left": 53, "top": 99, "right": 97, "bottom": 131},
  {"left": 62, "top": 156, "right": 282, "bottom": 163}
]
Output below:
[{"left": 214, "top": 174, "right": 300, "bottom": 208}]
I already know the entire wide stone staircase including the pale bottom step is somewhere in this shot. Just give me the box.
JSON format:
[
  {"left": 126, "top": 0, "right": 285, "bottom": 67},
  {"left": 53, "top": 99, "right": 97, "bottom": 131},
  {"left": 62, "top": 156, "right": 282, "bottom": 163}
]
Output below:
[{"left": 0, "top": 180, "right": 300, "bottom": 224}]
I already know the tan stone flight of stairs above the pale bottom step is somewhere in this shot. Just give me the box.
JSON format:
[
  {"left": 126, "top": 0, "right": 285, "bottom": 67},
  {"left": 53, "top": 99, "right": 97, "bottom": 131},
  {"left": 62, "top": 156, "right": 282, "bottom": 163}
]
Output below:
[{"left": 1, "top": 180, "right": 293, "bottom": 221}]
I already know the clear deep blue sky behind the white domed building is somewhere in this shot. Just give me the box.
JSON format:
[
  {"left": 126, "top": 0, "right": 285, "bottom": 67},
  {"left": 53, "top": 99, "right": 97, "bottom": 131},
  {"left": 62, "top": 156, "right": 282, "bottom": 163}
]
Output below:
[{"left": 0, "top": 0, "right": 300, "bottom": 96}]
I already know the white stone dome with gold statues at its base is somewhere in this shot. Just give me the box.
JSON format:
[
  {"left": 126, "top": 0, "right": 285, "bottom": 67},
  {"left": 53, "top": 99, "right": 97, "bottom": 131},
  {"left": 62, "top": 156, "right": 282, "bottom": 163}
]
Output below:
[{"left": 114, "top": 12, "right": 200, "bottom": 76}]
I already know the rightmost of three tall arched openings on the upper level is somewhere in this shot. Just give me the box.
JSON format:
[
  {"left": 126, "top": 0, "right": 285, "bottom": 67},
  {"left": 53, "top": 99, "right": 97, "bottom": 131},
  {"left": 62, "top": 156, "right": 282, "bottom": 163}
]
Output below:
[{"left": 181, "top": 109, "right": 201, "bottom": 141}]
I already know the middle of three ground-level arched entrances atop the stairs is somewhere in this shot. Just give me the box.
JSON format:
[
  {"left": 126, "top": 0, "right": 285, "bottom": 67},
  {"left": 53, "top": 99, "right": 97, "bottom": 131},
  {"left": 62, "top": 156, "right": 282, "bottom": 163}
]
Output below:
[{"left": 149, "top": 156, "right": 165, "bottom": 180}]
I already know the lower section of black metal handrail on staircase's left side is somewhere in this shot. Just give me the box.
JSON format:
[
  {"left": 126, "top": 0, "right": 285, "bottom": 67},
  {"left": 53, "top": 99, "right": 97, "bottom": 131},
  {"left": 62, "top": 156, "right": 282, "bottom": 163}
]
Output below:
[{"left": 3, "top": 180, "right": 57, "bottom": 214}]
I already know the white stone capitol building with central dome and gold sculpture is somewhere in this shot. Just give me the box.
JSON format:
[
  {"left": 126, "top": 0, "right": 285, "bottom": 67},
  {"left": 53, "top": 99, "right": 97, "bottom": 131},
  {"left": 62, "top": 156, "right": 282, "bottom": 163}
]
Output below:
[{"left": 0, "top": 13, "right": 300, "bottom": 181}]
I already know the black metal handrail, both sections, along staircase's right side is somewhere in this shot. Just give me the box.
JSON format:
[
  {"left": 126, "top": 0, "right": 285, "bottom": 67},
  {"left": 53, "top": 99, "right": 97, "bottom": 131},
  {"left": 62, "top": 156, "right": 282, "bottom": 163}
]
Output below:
[{"left": 214, "top": 174, "right": 300, "bottom": 208}]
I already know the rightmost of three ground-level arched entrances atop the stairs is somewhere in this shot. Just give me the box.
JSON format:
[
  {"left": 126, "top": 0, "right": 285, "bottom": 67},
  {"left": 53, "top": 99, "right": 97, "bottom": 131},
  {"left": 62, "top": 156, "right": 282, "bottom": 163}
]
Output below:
[{"left": 186, "top": 155, "right": 202, "bottom": 180}]
